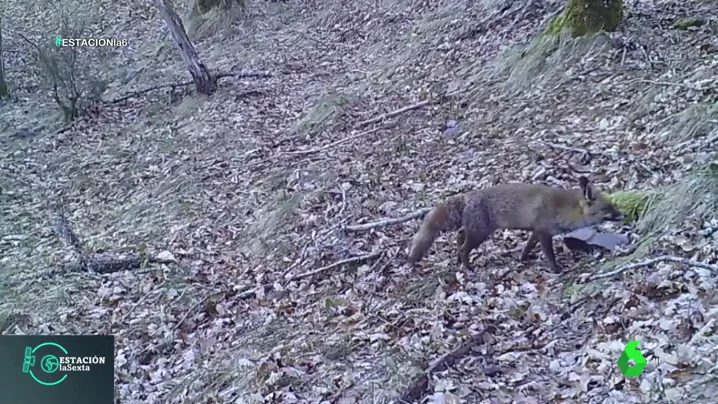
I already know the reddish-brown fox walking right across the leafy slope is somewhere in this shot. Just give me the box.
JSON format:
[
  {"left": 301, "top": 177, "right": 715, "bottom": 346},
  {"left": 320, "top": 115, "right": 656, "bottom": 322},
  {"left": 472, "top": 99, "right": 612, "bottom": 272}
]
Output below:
[{"left": 407, "top": 176, "right": 624, "bottom": 273}]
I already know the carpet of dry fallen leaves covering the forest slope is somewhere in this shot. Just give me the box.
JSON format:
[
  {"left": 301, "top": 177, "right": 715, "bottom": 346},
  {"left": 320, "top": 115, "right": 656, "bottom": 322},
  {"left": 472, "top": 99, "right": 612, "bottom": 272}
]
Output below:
[{"left": 0, "top": 0, "right": 718, "bottom": 404}]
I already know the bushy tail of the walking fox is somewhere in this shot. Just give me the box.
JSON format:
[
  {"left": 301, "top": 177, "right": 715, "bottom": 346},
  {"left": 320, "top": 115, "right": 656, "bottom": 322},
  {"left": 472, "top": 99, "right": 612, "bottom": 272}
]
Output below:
[{"left": 407, "top": 195, "right": 464, "bottom": 264}]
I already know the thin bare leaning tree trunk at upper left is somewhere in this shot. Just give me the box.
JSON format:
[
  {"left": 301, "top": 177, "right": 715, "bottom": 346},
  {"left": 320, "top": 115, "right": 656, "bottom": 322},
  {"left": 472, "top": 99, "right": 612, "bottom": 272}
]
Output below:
[{"left": 154, "top": 0, "right": 217, "bottom": 95}]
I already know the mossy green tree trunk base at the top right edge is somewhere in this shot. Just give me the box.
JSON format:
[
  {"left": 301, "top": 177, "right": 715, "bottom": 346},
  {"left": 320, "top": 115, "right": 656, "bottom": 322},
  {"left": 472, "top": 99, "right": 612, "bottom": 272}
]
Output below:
[{"left": 546, "top": 0, "right": 623, "bottom": 36}]
